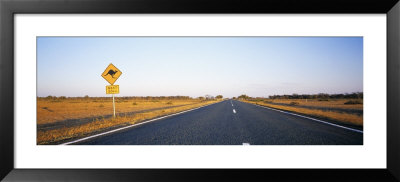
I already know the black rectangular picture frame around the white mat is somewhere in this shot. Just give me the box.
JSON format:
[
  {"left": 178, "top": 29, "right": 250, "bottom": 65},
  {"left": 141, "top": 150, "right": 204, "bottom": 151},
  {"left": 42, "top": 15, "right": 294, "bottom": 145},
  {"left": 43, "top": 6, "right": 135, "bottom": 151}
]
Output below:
[{"left": 0, "top": 0, "right": 400, "bottom": 181}]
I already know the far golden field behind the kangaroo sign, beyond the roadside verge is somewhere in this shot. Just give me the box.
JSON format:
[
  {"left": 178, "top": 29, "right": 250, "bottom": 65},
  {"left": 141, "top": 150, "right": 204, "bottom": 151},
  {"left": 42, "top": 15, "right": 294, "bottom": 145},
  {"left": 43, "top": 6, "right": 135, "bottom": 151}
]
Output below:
[{"left": 37, "top": 98, "right": 205, "bottom": 124}]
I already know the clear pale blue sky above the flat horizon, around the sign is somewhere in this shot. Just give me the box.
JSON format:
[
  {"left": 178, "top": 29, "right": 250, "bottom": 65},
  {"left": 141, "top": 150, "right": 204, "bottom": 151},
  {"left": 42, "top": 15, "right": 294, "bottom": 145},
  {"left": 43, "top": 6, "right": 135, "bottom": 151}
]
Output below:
[{"left": 37, "top": 37, "right": 363, "bottom": 97}]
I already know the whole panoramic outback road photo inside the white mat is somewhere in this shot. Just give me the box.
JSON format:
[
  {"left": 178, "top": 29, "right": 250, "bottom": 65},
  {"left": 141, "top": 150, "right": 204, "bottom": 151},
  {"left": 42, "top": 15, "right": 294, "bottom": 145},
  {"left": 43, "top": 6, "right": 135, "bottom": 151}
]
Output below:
[{"left": 36, "top": 37, "right": 364, "bottom": 145}]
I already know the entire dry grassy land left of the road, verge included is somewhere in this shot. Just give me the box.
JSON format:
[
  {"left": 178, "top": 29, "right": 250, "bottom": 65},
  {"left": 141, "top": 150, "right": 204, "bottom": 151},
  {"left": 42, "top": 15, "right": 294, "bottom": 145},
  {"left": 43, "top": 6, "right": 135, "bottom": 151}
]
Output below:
[{"left": 37, "top": 98, "right": 218, "bottom": 144}]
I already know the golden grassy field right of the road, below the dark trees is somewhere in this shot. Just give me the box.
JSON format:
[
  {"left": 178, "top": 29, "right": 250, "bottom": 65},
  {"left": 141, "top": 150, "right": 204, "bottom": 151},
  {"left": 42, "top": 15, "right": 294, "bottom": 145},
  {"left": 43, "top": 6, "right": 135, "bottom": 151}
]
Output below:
[{"left": 242, "top": 99, "right": 363, "bottom": 126}]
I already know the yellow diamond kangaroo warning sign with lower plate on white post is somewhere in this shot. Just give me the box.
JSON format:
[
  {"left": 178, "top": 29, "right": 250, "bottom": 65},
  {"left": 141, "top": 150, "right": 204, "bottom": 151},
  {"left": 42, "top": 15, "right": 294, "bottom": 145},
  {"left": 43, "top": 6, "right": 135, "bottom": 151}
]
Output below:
[{"left": 101, "top": 63, "right": 122, "bottom": 118}]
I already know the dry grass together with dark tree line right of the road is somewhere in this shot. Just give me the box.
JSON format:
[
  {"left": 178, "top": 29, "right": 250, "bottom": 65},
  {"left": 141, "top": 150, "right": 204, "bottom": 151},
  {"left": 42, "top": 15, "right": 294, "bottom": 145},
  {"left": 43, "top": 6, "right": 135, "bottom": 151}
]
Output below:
[{"left": 234, "top": 93, "right": 363, "bottom": 127}]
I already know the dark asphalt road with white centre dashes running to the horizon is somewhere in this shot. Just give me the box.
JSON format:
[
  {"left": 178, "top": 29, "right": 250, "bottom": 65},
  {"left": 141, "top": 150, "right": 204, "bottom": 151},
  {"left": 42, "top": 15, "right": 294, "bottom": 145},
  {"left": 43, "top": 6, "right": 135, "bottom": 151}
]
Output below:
[{"left": 75, "top": 100, "right": 363, "bottom": 145}]
